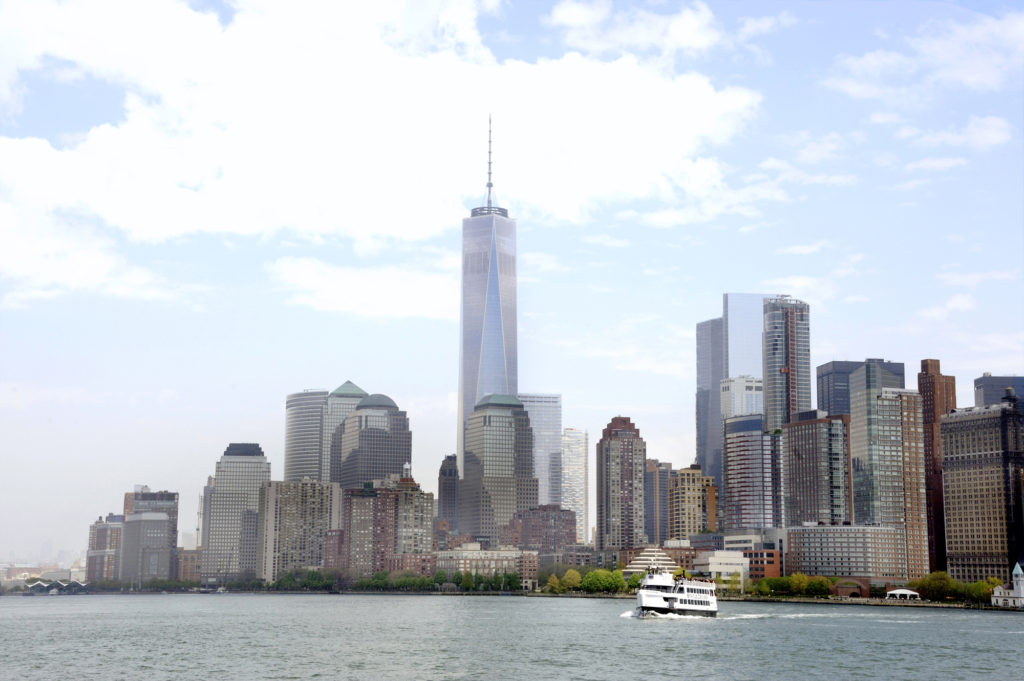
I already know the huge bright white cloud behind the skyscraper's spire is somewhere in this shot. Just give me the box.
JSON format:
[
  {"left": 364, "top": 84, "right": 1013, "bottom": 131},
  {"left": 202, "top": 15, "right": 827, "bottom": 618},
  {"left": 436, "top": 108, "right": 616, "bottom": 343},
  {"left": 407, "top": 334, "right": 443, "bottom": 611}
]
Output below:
[{"left": 0, "top": 0, "right": 761, "bottom": 304}]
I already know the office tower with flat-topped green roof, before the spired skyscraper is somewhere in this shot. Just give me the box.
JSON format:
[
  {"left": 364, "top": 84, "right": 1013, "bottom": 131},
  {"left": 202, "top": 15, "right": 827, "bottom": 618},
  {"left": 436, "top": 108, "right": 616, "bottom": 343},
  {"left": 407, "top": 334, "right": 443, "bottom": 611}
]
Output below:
[{"left": 459, "top": 395, "right": 537, "bottom": 546}]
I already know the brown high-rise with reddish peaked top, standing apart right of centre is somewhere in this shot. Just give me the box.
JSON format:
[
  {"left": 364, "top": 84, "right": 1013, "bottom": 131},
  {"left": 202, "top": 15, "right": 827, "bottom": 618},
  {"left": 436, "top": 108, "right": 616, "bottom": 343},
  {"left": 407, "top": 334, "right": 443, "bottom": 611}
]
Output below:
[{"left": 594, "top": 416, "right": 647, "bottom": 551}]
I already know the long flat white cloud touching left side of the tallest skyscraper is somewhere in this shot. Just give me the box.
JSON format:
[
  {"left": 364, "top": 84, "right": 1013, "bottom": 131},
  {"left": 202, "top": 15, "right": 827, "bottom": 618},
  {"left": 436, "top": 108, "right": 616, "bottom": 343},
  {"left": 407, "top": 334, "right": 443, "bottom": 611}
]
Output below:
[{"left": 265, "top": 257, "right": 459, "bottom": 321}]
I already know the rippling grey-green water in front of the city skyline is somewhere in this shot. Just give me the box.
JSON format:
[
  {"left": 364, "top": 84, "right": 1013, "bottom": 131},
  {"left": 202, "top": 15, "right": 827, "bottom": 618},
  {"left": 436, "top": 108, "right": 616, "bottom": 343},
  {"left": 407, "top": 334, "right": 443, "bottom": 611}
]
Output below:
[{"left": 0, "top": 594, "right": 1024, "bottom": 681}]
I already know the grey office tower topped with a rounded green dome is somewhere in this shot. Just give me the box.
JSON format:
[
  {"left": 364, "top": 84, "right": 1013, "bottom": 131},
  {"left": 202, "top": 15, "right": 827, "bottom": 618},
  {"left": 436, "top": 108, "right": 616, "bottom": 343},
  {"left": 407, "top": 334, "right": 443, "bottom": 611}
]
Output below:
[{"left": 338, "top": 394, "right": 413, "bottom": 490}]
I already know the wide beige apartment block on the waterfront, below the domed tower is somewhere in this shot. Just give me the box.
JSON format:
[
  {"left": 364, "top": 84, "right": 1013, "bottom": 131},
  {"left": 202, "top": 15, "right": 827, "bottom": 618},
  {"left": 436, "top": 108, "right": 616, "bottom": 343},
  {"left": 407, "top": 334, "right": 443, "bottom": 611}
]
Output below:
[{"left": 256, "top": 480, "right": 342, "bottom": 582}]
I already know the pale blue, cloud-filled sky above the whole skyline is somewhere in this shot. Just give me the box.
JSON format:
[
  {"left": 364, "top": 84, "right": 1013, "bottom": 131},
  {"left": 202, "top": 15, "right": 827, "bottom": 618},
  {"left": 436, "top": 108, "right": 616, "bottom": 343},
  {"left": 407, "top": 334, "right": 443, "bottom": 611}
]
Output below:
[{"left": 0, "top": 0, "right": 1024, "bottom": 561}]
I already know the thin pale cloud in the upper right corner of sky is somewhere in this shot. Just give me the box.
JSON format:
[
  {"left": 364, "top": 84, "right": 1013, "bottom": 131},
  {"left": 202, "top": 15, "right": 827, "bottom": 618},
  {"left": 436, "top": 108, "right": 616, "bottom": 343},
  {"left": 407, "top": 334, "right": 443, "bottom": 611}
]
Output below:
[{"left": 824, "top": 12, "right": 1024, "bottom": 100}]
